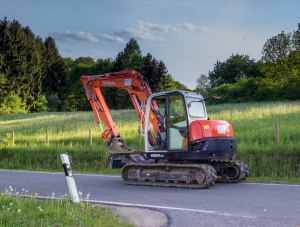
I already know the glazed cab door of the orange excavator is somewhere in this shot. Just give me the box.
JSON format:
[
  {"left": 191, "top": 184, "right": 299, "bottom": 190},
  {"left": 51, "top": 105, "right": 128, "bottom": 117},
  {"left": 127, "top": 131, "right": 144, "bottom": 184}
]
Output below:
[{"left": 167, "top": 93, "right": 188, "bottom": 150}]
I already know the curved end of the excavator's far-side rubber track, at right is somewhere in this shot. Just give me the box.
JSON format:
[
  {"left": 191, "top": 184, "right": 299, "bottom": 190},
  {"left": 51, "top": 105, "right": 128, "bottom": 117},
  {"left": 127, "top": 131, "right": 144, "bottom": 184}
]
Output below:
[{"left": 217, "top": 160, "right": 249, "bottom": 183}]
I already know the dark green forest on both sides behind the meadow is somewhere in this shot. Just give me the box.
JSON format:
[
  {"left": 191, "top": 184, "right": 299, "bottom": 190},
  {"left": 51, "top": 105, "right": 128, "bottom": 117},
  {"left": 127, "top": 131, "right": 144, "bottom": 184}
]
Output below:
[{"left": 0, "top": 18, "right": 300, "bottom": 114}]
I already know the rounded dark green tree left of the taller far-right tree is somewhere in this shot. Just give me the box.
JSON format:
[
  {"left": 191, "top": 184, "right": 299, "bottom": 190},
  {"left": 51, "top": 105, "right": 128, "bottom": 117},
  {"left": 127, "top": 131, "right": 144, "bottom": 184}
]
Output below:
[{"left": 208, "top": 54, "right": 262, "bottom": 87}]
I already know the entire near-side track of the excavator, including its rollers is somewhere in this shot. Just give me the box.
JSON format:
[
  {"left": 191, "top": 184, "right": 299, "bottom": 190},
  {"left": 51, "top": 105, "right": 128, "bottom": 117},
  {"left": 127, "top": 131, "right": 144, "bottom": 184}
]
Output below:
[{"left": 122, "top": 162, "right": 217, "bottom": 189}]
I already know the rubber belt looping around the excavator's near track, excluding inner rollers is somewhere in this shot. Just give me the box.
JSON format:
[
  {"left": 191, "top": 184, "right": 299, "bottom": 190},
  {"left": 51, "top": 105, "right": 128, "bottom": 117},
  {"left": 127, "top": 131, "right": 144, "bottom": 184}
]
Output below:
[{"left": 122, "top": 163, "right": 217, "bottom": 189}]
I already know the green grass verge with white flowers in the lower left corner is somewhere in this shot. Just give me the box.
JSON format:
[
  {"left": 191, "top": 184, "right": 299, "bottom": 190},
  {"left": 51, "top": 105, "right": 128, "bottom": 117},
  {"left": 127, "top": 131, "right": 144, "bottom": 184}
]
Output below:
[{"left": 0, "top": 193, "right": 133, "bottom": 227}]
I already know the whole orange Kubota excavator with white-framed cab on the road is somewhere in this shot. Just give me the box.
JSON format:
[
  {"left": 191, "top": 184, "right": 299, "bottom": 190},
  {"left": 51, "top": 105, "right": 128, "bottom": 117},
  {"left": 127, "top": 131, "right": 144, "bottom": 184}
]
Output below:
[{"left": 81, "top": 70, "right": 249, "bottom": 189}]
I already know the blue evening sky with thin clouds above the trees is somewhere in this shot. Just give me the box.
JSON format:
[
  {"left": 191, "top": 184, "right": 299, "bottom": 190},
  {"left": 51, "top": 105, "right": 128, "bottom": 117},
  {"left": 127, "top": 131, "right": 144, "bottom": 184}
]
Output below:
[{"left": 0, "top": 0, "right": 300, "bottom": 89}]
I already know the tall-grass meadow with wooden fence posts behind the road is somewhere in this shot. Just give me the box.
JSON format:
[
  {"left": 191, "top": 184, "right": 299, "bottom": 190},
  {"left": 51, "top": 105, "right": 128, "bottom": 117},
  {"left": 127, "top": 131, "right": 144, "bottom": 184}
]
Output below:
[{"left": 0, "top": 102, "right": 300, "bottom": 183}]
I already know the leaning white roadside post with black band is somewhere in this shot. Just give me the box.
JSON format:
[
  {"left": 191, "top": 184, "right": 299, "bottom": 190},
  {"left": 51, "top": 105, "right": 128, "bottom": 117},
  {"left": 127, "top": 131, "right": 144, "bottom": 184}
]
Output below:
[{"left": 60, "top": 154, "right": 80, "bottom": 203}]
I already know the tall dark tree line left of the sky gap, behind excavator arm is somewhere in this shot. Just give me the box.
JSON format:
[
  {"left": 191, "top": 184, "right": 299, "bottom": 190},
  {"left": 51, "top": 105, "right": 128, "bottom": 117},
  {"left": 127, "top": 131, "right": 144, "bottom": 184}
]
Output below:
[{"left": 0, "top": 17, "right": 187, "bottom": 114}]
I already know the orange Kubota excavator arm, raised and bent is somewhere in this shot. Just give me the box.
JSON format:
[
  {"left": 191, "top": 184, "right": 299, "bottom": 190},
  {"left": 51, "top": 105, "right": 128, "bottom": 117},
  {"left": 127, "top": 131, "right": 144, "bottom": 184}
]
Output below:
[{"left": 81, "top": 70, "right": 159, "bottom": 148}]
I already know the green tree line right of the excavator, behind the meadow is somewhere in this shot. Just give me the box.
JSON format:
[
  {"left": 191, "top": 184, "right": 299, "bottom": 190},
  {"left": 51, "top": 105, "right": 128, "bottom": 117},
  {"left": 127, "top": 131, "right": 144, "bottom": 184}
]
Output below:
[{"left": 197, "top": 24, "right": 300, "bottom": 103}]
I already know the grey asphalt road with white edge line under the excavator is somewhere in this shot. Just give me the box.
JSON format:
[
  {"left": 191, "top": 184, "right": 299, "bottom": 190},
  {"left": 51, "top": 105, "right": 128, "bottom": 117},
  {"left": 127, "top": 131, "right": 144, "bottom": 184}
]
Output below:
[{"left": 0, "top": 170, "right": 300, "bottom": 227}]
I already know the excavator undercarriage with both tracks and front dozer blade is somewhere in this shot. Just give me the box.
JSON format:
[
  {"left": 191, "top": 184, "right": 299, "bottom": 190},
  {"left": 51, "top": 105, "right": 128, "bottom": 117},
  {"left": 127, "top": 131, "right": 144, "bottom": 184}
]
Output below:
[{"left": 109, "top": 153, "right": 249, "bottom": 189}]
